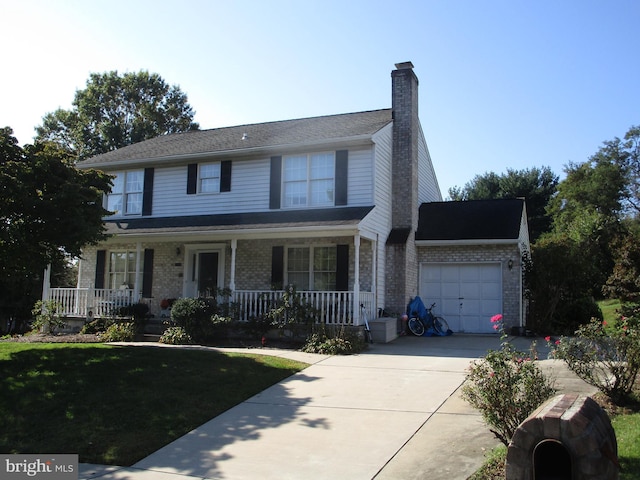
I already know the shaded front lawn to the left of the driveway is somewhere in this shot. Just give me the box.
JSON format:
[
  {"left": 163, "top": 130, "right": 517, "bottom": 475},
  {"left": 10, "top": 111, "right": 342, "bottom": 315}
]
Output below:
[{"left": 0, "top": 343, "right": 307, "bottom": 466}]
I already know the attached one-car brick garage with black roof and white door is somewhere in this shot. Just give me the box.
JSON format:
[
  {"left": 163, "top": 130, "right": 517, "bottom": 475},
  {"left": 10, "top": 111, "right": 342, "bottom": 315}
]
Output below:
[{"left": 416, "top": 199, "right": 529, "bottom": 334}]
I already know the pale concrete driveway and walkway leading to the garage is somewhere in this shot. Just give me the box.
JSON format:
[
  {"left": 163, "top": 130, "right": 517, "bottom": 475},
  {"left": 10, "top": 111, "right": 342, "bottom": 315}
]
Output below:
[{"left": 79, "top": 335, "right": 594, "bottom": 480}]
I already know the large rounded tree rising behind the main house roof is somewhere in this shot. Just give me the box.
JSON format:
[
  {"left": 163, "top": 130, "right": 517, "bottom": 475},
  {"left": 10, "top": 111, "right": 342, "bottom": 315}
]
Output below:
[{"left": 36, "top": 71, "right": 199, "bottom": 159}]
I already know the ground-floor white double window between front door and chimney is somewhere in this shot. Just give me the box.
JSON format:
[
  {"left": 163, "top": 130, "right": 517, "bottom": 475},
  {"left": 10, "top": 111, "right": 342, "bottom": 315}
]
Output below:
[{"left": 286, "top": 246, "right": 337, "bottom": 290}]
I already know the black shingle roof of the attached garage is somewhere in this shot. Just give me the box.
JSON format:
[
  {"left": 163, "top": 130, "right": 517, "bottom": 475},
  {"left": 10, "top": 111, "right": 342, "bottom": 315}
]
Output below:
[{"left": 416, "top": 199, "right": 525, "bottom": 240}]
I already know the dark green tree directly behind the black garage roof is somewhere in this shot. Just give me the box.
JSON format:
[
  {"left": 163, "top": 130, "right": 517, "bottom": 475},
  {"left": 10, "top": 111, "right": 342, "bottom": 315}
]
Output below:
[{"left": 449, "top": 167, "right": 558, "bottom": 241}]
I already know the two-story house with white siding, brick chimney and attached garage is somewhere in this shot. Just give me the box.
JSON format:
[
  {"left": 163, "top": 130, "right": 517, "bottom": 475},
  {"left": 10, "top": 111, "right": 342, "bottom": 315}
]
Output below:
[{"left": 47, "top": 62, "right": 528, "bottom": 332}]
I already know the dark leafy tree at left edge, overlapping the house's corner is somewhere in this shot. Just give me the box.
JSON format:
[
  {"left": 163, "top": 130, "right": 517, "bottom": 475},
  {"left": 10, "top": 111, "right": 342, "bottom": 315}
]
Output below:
[{"left": 0, "top": 127, "right": 111, "bottom": 330}]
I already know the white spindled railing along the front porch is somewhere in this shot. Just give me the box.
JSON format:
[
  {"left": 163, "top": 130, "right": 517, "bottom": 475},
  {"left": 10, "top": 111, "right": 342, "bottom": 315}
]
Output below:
[{"left": 49, "top": 288, "right": 376, "bottom": 325}]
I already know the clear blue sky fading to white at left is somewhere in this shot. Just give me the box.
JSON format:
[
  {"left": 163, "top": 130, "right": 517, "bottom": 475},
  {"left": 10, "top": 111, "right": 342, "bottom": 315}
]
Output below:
[{"left": 0, "top": 0, "right": 640, "bottom": 197}]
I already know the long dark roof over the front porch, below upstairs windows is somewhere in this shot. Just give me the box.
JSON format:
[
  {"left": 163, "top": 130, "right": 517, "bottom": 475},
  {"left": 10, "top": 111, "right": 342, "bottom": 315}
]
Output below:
[{"left": 105, "top": 206, "right": 374, "bottom": 235}]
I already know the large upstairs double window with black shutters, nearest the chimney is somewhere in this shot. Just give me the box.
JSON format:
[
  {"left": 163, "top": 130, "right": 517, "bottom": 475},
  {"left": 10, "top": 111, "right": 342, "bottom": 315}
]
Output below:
[{"left": 282, "top": 153, "right": 335, "bottom": 208}]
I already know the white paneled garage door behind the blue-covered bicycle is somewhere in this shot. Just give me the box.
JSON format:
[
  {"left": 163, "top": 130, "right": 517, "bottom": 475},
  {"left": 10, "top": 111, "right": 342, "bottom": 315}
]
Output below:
[{"left": 419, "top": 263, "right": 502, "bottom": 333}]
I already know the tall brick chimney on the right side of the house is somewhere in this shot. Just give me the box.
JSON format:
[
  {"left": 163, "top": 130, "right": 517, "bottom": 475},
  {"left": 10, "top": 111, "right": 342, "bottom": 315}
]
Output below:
[{"left": 385, "top": 62, "right": 420, "bottom": 312}]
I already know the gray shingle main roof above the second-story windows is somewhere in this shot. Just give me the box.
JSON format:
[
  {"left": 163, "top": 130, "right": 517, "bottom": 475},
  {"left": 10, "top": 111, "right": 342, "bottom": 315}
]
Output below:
[{"left": 78, "top": 109, "right": 391, "bottom": 167}]
